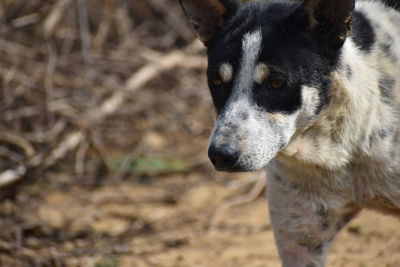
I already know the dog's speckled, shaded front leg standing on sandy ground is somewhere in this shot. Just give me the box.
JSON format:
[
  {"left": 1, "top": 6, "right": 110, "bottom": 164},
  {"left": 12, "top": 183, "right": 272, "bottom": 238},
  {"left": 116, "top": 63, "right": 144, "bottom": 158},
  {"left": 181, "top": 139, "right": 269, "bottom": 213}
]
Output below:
[{"left": 267, "top": 175, "right": 359, "bottom": 267}]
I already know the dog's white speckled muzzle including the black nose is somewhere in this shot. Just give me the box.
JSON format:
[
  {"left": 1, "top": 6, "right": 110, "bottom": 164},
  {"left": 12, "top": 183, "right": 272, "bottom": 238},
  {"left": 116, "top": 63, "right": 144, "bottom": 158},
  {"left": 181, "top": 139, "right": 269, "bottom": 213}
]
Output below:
[{"left": 208, "top": 112, "right": 294, "bottom": 172}]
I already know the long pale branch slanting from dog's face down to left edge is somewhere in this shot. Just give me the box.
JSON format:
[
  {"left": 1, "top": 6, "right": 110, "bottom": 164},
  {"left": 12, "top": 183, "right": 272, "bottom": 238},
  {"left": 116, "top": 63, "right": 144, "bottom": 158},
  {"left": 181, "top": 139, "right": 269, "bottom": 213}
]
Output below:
[{"left": 0, "top": 40, "right": 205, "bottom": 187}]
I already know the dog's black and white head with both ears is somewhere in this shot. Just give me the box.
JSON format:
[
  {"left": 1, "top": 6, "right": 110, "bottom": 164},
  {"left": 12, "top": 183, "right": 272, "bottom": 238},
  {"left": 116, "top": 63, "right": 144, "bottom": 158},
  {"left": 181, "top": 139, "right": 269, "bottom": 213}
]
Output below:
[{"left": 179, "top": 0, "right": 354, "bottom": 172}]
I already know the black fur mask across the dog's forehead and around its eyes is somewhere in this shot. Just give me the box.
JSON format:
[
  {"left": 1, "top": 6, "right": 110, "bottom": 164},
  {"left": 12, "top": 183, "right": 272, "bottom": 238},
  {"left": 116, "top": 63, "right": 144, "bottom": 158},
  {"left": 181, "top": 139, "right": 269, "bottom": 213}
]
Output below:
[{"left": 208, "top": 0, "right": 339, "bottom": 114}]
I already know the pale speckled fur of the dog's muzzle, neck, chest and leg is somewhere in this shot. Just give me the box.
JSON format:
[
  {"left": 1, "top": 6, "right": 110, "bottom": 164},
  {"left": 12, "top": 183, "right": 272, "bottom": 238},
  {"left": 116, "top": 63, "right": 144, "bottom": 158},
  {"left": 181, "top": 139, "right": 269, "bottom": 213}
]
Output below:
[{"left": 181, "top": 0, "right": 400, "bottom": 267}]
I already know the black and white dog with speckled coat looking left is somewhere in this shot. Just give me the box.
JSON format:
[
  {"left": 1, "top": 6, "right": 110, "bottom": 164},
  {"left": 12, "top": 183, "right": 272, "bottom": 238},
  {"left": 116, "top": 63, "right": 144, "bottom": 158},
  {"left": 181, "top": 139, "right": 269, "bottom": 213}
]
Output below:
[{"left": 180, "top": 0, "right": 400, "bottom": 267}]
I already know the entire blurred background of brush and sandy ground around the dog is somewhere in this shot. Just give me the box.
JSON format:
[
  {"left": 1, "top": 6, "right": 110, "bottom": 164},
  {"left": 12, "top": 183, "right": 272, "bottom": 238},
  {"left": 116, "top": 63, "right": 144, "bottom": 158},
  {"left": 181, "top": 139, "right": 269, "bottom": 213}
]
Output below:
[{"left": 0, "top": 0, "right": 400, "bottom": 267}]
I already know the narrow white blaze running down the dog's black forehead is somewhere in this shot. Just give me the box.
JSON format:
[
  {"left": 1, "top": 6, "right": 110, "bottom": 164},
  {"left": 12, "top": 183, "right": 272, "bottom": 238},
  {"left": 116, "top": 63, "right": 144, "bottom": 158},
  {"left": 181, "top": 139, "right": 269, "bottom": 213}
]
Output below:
[{"left": 235, "top": 29, "right": 262, "bottom": 91}]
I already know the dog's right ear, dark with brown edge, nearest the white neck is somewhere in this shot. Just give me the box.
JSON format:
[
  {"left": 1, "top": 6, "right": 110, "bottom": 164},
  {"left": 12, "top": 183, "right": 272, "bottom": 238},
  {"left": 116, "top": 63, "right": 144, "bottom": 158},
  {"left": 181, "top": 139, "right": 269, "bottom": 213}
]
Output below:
[{"left": 300, "top": 0, "right": 355, "bottom": 48}]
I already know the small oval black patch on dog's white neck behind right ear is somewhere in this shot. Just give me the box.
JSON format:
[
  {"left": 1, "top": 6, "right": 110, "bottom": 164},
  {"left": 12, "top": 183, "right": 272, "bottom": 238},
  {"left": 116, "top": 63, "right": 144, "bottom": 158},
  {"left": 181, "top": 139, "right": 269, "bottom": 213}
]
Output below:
[{"left": 352, "top": 11, "right": 376, "bottom": 52}]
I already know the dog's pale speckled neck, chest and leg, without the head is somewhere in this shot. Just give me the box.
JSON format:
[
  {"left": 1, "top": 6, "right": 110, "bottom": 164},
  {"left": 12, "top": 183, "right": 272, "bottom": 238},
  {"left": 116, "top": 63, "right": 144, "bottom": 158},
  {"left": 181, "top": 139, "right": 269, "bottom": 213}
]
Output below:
[{"left": 268, "top": 2, "right": 400, "bottom": 267}]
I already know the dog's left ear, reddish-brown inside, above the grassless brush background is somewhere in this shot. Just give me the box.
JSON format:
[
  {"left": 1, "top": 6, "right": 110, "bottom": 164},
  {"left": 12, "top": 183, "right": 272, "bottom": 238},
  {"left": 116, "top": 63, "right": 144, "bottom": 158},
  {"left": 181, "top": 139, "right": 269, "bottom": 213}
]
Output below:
[{"left": 179, "top": 0, "right": 239, "bottom": 45}]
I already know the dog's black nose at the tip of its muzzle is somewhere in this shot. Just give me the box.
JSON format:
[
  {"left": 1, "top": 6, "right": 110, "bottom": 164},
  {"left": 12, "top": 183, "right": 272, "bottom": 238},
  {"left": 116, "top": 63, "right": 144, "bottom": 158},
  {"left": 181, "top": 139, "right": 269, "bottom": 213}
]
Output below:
[{"left": 208, "top": 144, "right": 239, "bottom": 170}]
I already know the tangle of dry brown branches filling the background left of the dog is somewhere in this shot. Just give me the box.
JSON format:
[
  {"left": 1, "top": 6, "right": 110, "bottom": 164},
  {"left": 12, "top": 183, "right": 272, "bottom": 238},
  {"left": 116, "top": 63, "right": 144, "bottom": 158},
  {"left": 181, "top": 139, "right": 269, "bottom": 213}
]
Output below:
[{"left": 0, "top": 0, "right": 216, "bottom": 266}]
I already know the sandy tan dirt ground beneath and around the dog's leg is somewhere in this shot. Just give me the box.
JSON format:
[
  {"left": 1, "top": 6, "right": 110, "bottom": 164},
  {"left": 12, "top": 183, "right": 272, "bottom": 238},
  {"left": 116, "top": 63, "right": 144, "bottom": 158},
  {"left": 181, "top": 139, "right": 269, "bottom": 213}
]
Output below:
[{"left": 0, "top": 171, "right": 400, "bottom": 267}]
